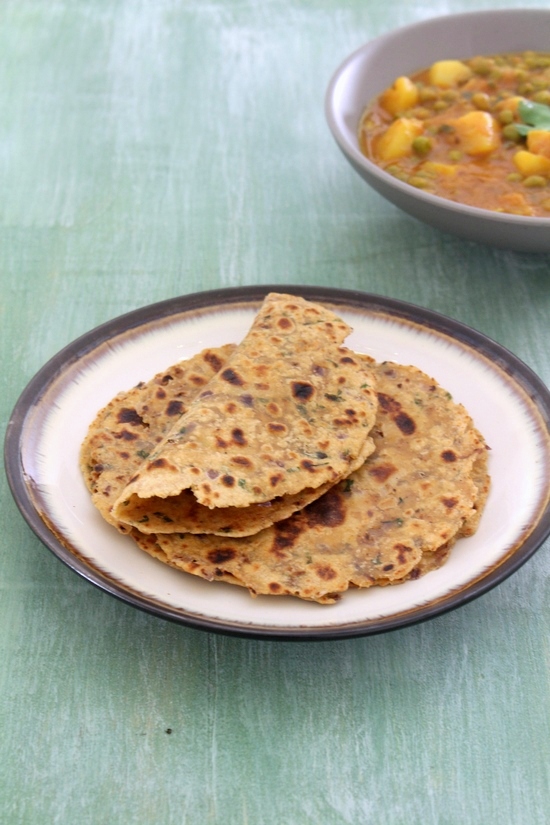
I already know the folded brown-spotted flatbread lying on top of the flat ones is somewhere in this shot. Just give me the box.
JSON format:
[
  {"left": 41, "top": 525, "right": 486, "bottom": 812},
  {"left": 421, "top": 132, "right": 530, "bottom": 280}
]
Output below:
[{"left": 113, "top": 293, "right": 377, "bottom": 536}]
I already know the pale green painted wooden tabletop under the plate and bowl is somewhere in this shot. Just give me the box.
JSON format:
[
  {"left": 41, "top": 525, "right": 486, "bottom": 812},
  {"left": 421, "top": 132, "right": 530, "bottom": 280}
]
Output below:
[{"left": 0, "top": 0, "right": 550, "bottom": 825}]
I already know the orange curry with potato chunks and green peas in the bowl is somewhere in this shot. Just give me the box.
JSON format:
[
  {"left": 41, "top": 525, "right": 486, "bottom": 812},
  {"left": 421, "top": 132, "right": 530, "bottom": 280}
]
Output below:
[{"left": 359, "top": 52, "right": 550, "bottom": 218}]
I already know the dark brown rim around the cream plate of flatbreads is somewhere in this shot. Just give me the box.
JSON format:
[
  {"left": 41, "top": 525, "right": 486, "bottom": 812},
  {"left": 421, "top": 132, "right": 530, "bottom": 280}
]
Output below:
[{"left": 4, "top": 284, "right": 550, "bottom": 641}]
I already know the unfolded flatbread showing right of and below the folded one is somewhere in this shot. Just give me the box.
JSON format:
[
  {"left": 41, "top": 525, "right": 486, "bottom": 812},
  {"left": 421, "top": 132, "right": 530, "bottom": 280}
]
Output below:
[{"left": 131, "top": 363, "right": 489, "bottom": 604}]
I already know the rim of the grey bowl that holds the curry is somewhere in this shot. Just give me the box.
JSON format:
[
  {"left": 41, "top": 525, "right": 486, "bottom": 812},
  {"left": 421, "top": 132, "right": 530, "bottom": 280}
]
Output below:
[{"left": 324, "top": 8, "right": 550, "bottom": 229}]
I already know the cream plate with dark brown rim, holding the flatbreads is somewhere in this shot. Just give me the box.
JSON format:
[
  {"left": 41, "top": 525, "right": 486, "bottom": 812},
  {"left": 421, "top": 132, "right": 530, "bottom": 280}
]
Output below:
[{"left": 5, "top": 285, "right": 550, "bottom": 639}]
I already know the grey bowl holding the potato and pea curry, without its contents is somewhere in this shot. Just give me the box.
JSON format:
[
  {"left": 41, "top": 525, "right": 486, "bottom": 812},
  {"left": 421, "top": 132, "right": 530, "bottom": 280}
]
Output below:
[{"left": 325, "top": 9, "right": 550, "bottom": 252}]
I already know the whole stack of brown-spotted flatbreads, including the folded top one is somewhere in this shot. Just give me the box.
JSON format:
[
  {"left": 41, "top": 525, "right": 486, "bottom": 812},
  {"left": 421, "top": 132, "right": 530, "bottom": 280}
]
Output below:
[{"left": 81, "top": 294, "right": 489, "bottom": 604}]
